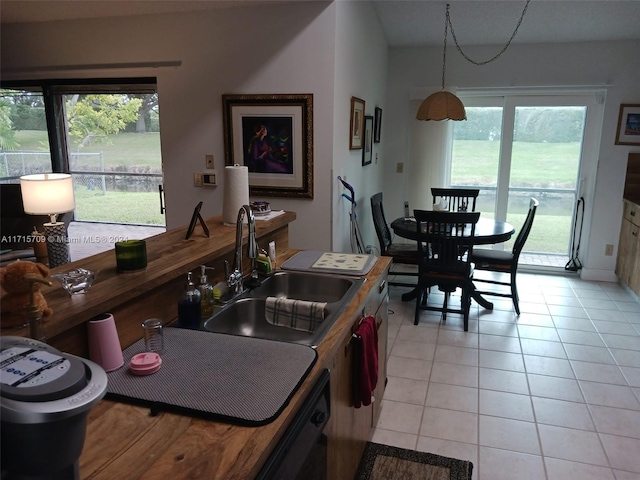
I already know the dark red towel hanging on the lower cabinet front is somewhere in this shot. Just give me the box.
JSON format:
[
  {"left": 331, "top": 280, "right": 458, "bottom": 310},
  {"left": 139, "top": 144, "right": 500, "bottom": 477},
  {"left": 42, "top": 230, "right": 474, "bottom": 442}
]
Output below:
[{"left": 352, "top": 315, "right": 378, "bottom": 408}]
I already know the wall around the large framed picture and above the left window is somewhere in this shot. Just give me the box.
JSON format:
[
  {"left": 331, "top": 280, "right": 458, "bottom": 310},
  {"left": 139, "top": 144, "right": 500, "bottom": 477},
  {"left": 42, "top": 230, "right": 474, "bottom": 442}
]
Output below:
[{"left": 0, "top": 2, "right": 340, "bottom": 250}]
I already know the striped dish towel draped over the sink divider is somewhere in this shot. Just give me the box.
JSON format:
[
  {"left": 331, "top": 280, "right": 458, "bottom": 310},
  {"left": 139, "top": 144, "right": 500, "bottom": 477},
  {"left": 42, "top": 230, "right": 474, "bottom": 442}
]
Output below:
[{"left": 265, "top": 297, "right": 327, "bottom": 332}]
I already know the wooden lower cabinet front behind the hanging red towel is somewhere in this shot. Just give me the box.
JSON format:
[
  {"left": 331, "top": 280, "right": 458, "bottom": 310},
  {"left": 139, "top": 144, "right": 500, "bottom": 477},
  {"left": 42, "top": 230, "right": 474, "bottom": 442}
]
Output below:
[{"left": 327, "top": 274, "right": 389, "bottom": 480}]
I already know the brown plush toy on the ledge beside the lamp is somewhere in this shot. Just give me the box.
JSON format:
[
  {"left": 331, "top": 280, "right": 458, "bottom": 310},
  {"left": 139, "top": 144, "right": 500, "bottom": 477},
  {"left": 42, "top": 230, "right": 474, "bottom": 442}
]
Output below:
[{"left": 0, "top": 260, "right": 53, "bottom": 327}]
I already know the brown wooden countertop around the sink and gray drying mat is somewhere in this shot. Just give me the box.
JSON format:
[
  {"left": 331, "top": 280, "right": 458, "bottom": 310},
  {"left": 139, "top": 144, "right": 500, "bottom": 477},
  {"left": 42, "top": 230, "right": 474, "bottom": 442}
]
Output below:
[{"left": 80, "top": 255, "right": 390, "bottom": 480}]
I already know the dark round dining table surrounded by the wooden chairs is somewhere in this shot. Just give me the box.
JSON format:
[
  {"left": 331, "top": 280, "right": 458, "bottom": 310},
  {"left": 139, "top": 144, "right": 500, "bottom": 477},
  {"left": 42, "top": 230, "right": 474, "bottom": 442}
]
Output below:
[{"left": 391, "top": 215, "right": 516, "bottom": 310}]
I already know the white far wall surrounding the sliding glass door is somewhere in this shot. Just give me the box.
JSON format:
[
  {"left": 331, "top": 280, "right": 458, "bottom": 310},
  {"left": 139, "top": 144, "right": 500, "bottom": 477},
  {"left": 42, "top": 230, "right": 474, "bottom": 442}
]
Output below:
[{"left": 383, "top": 41, "right": 640, "bottom": 281}]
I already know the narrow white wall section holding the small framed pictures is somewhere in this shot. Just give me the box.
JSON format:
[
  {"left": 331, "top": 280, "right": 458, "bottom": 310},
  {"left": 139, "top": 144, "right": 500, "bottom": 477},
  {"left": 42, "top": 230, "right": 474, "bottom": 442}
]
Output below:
[{"left": 330, "top": 2, "right": 392, "bottom": 252}]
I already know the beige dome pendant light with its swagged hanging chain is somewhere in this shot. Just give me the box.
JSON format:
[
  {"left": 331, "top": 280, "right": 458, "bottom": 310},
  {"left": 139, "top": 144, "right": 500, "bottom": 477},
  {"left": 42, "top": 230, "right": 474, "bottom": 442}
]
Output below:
[{"left": 416, "top": 0, "right": 531, "bottom": 121}]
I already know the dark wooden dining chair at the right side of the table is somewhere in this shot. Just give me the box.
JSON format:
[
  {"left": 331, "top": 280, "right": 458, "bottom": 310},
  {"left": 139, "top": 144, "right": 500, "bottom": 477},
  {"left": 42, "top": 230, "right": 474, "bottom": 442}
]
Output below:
[{"left": 471, "top": 198, "right": 539, "bottom": 315}]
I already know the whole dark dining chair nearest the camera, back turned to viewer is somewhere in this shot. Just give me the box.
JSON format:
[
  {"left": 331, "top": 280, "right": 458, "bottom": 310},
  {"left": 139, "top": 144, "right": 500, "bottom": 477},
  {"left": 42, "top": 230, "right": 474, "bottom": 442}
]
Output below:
[{"left": 413, "top": 210, "right": 480, "bottom": 332}]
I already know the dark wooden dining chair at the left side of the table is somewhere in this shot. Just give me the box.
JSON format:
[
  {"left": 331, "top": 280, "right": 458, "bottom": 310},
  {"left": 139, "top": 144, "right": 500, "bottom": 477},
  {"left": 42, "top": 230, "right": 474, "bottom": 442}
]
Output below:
[{"left": 371, "top": 192, "right": 418, "bottom": 287}]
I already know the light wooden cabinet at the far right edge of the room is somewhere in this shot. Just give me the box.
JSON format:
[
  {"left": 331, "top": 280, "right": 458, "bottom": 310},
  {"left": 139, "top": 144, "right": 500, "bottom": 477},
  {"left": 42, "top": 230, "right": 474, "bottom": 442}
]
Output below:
[{"left": 616, "top": 200, "right": 640, "bottom": 296}]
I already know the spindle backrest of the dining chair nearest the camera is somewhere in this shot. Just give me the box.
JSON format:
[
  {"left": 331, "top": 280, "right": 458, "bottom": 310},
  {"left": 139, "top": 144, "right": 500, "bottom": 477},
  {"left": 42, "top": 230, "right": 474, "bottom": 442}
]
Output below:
[{"left": 413, "top": 210, "right": 480, "bottom": 275}]
